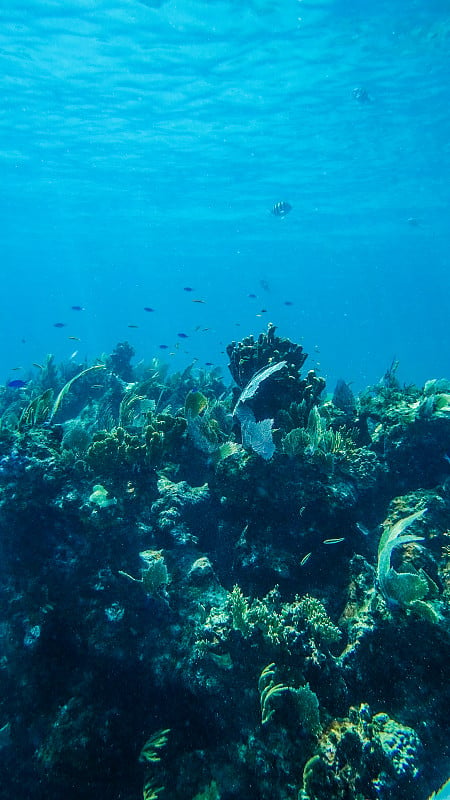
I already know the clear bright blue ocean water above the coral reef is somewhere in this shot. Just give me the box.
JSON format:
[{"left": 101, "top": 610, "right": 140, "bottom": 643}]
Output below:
[{"left": 0, "top": 0, "right": 450, "bottom": 388}]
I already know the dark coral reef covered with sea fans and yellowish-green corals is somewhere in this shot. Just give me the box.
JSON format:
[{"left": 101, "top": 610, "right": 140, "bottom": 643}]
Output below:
[{"left": 0, "top": 325, "right": 450, "bottom": 800}]
